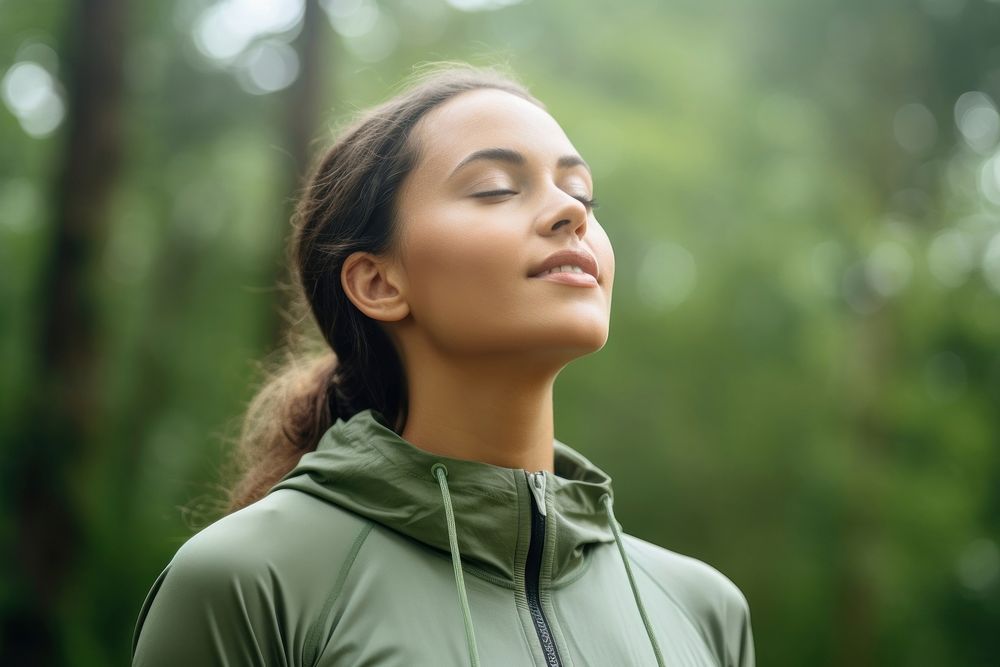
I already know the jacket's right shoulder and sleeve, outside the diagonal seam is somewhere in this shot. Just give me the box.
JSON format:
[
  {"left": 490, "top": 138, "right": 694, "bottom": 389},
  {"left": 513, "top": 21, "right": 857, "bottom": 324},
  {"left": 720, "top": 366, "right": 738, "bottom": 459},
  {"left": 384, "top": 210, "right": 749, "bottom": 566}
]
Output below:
[{"left": 624, "top": 535, "right": 754, "bottom": 666}]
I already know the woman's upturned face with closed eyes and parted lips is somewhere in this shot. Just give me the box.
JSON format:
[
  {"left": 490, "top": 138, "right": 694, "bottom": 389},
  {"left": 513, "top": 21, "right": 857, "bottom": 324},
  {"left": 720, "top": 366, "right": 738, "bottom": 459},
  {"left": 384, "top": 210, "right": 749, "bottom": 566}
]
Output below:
[{"left": 386, "top": 89, "right": 615, "bottom": 361}]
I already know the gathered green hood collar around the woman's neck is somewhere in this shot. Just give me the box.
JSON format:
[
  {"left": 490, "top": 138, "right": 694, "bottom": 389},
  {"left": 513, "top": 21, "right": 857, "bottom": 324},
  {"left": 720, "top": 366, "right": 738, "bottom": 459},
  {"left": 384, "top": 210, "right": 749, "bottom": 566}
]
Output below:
[{"left": 271, "top": 409, "right": 615, "bottom": 586}]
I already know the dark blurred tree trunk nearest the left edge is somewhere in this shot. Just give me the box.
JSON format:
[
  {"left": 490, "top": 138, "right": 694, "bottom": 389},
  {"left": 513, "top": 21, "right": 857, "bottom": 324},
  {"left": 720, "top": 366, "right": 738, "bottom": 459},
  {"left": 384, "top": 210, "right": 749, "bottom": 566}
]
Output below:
[{"left": 0, "top": 0, "right": 127, "bottom": 665}]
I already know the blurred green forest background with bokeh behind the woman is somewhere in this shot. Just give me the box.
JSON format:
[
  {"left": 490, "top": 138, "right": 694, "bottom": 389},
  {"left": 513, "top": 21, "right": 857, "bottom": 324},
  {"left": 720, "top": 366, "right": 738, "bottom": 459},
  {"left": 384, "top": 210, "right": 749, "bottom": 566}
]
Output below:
[{"left": 0, "top": 0, "right": 1000, "bottom": 667}]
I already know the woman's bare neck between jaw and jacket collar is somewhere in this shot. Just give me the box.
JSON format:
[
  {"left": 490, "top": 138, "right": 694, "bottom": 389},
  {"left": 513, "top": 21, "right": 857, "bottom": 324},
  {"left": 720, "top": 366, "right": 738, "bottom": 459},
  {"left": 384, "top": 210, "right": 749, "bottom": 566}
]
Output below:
[{"left": 400, "top": 357, "right": 558, "bottom": 473}]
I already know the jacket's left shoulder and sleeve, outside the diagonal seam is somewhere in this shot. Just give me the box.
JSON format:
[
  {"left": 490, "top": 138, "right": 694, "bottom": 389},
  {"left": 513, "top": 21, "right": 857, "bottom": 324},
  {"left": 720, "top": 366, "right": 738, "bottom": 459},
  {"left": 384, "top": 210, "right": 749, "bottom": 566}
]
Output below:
[{"left": 132, "top": 489, "right": 370, "bottom": 665}]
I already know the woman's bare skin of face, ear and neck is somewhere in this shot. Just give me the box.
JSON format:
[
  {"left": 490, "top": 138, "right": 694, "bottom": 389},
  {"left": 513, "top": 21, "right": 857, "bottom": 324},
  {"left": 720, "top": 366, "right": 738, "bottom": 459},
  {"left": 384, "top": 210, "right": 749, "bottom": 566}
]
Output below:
[{"left": 341, "top": 89, "right": 615, "bottom": 472}]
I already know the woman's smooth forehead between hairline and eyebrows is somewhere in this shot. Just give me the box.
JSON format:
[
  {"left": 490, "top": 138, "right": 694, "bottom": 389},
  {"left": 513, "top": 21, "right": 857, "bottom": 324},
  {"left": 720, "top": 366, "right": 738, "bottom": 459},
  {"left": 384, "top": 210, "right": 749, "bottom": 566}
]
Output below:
[{"left": 414, "top": 89, "right": 576, "bottom": 177}]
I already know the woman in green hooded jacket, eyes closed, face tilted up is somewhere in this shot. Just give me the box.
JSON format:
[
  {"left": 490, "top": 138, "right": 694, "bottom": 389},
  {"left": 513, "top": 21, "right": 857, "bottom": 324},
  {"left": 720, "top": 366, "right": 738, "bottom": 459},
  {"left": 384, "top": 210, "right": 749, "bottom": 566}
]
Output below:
[{"left": 132, "top": 66, "right": 754, "bottom": 667}]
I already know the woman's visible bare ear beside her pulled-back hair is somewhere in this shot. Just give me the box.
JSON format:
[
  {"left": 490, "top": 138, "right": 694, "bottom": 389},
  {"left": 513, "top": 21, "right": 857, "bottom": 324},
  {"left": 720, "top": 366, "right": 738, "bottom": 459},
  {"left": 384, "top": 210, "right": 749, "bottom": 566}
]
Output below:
[{"left": 340, "top": 250, "right": 410, "bottom": 322}]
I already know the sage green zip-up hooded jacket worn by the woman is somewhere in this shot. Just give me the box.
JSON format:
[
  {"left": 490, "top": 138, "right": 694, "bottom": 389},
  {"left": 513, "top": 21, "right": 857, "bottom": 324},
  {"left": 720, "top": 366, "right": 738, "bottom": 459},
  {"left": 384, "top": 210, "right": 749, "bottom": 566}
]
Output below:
[{"left": 132, "top": 410, "right": 754, "bottom": 667}]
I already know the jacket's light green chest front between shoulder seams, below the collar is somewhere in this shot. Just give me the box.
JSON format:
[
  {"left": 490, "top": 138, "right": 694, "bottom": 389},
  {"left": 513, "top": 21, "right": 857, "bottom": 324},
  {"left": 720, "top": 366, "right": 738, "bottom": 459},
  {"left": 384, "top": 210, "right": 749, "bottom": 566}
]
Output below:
[{"left": 317, "top": 543, "right": 719, "bottom": 667}]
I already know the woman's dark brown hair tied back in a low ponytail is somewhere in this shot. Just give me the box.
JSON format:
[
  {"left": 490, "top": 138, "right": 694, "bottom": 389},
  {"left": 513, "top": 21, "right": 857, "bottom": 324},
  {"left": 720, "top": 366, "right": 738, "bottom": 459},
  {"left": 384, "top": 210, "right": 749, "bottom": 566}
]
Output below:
[{"left": 224, "top": 63, "right": 545, "bottom": 513}]
